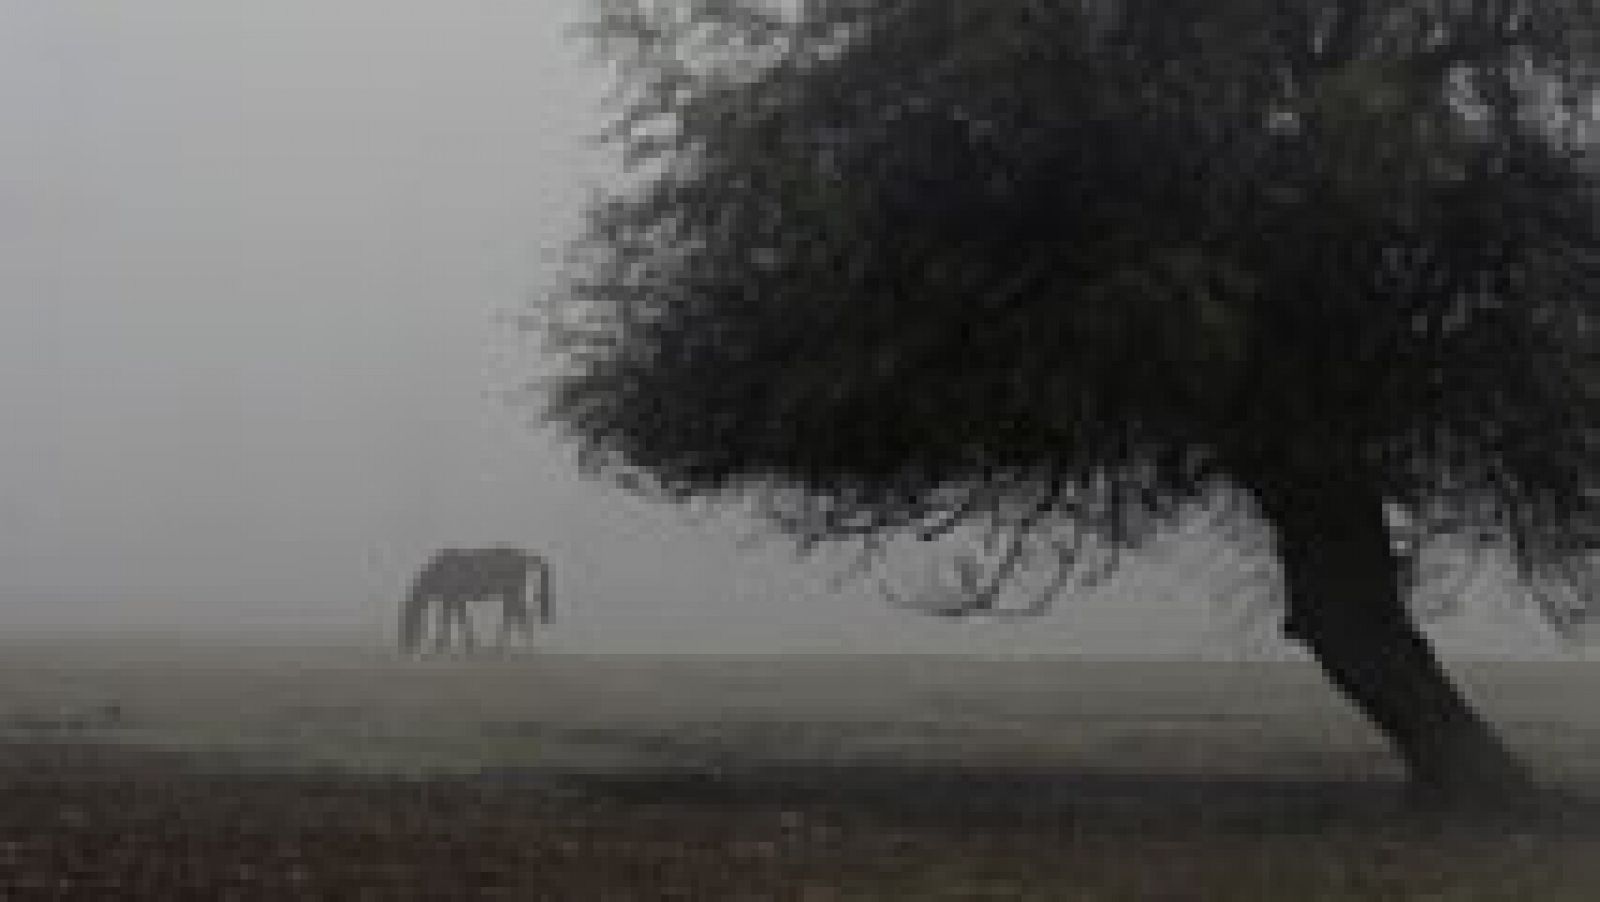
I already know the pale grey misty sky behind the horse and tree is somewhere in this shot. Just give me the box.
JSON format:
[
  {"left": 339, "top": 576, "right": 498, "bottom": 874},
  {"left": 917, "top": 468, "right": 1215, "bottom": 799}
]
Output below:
[{"left": 0, "top": 0, "right": 1574, "bottom": 653}]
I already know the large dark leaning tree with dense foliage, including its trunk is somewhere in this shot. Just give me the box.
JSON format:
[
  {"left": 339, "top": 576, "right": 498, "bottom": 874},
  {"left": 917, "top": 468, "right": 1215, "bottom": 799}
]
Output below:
[{"left": 550, "top": 0, "right": 1600, "bottom": 798}]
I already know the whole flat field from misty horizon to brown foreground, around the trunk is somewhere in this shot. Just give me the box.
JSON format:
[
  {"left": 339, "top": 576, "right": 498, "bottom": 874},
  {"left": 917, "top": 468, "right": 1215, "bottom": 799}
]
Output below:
[{"left": 0, "top": 641, "right": 1600, "bottom": 900}]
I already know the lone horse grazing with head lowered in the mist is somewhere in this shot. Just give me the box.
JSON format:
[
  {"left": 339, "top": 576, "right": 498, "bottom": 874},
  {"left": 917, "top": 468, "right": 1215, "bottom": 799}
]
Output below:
[{"left": 400, "top": 545, "right": 550, "bottom": 651}]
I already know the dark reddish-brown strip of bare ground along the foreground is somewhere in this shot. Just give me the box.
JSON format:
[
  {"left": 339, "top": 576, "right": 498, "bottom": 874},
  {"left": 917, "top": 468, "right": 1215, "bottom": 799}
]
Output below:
[{"left": 9, "top": 742, "right": 1600, "bottom": 902}]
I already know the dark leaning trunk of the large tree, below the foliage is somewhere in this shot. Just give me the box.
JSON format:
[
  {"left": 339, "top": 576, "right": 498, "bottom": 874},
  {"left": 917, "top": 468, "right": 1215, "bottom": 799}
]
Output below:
[{"left": 1251, "top": 480, "right": 1531, "bottom": 804}]
